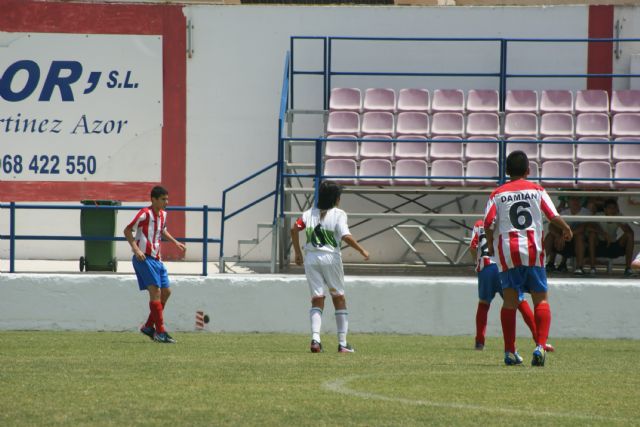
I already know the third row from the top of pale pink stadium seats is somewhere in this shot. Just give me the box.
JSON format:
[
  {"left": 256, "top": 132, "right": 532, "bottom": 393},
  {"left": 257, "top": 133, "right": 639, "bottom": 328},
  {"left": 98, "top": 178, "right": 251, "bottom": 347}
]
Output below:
[{"left": 324, "top": 135, "right": 640, "bottom": 163}]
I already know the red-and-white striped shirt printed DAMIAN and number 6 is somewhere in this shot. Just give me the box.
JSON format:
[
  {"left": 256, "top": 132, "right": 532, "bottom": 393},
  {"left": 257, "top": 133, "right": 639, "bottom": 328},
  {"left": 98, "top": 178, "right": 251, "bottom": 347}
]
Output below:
[{"left": 484, "top": 179, "right": 558, "bottom": 271}]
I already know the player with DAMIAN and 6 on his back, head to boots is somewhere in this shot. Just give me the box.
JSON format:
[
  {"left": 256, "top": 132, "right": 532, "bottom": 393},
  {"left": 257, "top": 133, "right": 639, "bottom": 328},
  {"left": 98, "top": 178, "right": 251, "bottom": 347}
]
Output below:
[{"left": 484, "top": 151, "right": 573, "bottom": 366}]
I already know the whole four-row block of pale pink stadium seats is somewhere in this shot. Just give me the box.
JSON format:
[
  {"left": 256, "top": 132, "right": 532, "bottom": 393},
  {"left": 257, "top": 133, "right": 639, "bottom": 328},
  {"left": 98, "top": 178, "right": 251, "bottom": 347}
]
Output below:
[{"left": 324, "top": 88, "right": 640, "bottom": 189}]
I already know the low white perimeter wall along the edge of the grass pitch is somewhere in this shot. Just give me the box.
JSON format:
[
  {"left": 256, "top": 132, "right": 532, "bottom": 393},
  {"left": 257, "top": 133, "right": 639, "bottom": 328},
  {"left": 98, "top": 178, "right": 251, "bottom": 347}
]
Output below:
[{"left": 0, "top": 274, "right": 640, "bottom": 339}]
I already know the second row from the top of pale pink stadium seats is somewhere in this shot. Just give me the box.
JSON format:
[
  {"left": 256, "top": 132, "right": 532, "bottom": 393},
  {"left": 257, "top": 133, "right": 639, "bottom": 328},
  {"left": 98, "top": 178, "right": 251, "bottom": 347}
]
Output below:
[{"left": 327, "top": 111, "right": 640, "bottom": 138}]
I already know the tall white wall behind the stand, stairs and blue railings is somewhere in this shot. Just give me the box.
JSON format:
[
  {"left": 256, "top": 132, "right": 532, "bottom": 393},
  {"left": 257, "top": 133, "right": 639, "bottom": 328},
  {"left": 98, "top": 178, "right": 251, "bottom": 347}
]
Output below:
[{"left": 8, "top": 5, "right": 637, "bottom": 262}]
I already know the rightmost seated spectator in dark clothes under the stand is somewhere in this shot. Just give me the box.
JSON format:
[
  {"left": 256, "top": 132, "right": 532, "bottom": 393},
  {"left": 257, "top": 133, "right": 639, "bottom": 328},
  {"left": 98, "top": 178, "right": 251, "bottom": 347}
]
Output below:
[{"left": 589, "top": 199, "right": 634, "bottom": 276}]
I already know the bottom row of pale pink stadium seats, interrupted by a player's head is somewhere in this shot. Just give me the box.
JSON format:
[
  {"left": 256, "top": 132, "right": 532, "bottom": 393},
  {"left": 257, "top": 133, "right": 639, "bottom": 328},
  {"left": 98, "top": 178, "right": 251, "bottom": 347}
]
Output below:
[{"left": 324, "top": 159, "right": 640, "bottom": 188}]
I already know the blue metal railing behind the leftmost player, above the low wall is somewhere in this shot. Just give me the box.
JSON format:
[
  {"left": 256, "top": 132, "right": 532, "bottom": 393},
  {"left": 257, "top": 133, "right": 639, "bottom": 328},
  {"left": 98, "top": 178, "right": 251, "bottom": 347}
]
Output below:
[{"left": 0, "top": 202, "right": 222, "bottom": 276}]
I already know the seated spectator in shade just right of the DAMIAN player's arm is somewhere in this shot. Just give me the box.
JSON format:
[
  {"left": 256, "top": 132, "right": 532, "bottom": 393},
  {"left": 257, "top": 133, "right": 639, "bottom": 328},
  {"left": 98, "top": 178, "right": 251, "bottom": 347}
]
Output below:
[{"left": 544, "top": 196, "right": 591, "bottom": 275}]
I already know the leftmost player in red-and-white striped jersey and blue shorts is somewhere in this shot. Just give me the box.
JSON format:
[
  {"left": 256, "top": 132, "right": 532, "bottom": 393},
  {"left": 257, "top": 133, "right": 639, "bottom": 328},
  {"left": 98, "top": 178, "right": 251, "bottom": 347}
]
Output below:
[{"left": 124, "top": 186, "right": 186, "bottom": 343}]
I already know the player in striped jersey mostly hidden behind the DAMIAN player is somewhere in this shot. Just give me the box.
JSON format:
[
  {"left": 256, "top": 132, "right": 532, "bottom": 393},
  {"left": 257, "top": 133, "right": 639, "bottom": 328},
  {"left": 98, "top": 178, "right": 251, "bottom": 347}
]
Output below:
[{"left": 469, "top": 219, "right": 554, "bottom": 351}]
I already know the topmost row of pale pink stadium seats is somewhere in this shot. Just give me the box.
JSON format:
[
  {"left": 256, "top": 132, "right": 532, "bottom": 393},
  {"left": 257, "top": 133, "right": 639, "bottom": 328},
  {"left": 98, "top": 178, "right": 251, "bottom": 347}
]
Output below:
[{"left": 329, "top": 88, "right": 640, "bottom": 115}]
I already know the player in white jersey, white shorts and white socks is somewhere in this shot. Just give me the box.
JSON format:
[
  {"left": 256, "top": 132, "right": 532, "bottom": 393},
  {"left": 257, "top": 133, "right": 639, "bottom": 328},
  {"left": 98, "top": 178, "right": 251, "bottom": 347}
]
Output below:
[{"left": 291, "top": 181, "right": 369, "bottom": 353}]
